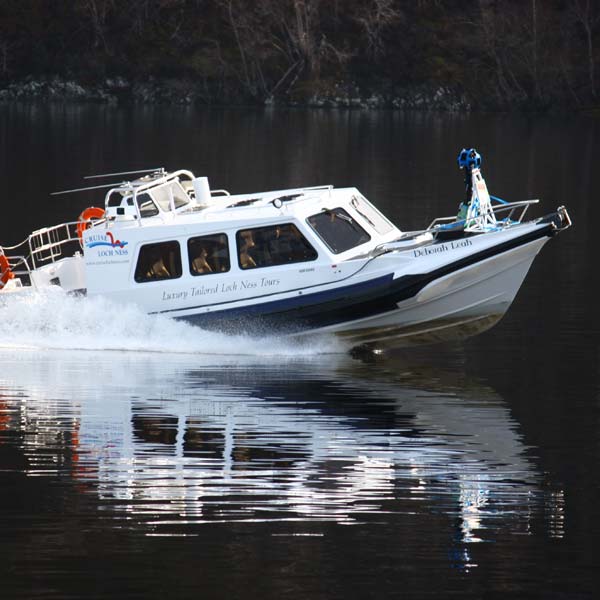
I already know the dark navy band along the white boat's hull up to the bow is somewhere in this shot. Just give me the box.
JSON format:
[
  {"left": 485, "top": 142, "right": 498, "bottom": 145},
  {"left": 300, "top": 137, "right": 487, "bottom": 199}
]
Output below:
[{"left": 175, "top": 225, "right": 553, "bottom": 333}]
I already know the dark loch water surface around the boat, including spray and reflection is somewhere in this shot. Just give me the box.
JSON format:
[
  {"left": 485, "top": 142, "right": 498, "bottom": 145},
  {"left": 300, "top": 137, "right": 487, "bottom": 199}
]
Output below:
[{"left": 0, "top": 105, "right": 600, "bottom": 599}]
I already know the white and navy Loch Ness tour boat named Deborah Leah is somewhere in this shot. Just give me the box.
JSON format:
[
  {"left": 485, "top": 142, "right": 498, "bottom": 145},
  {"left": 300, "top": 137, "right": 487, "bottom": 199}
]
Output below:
[{"left": 0, "top": 148, "right": 571, "bottom": 348}]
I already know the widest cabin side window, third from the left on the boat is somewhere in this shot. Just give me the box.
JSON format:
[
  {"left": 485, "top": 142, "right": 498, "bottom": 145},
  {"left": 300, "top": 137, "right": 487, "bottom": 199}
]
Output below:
[{"left": 236, "top": 223, "right": 318, "bottom": 269}]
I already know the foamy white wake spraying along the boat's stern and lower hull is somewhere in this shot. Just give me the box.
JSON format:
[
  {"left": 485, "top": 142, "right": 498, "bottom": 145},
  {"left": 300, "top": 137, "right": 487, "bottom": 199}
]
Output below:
[{"left": 0, "top": 287, "right": 347, "bottom": 356}]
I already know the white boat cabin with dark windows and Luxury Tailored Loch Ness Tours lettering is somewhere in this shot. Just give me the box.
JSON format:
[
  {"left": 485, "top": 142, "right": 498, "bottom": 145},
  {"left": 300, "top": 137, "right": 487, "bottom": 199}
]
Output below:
[{"left": 74, "top": 171, "right": 400, "bottom": 312}]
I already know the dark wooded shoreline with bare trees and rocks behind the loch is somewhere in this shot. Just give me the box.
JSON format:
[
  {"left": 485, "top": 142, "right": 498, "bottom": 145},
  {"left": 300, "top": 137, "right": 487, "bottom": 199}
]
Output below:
[{"left": 0, "top": 0, "right": 600, "bottom": 111}]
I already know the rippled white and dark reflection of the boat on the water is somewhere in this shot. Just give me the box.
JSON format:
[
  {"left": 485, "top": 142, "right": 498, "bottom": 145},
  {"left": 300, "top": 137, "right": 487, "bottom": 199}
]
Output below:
[{"left": 0, "top": 351, "right": 562, "bottom": 560}]
